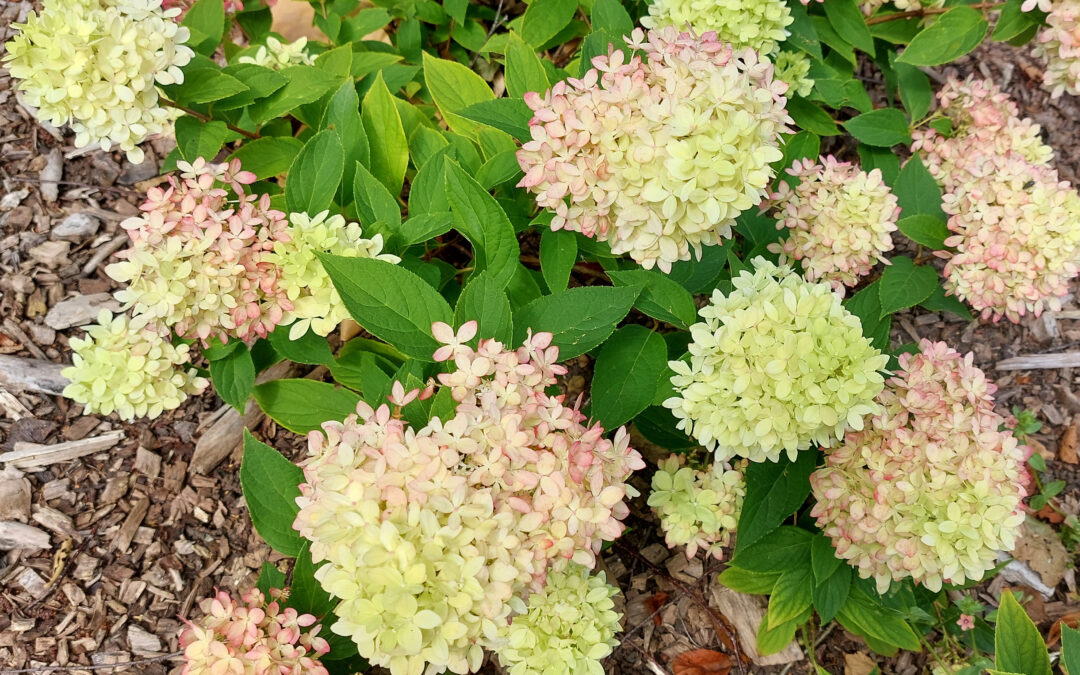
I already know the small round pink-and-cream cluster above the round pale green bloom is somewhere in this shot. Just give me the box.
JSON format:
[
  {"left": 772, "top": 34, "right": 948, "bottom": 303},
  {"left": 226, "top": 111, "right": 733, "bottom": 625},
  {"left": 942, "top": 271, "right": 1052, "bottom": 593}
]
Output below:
[{"left": 770, "top": 156, "right": 900, "bottom": 296}]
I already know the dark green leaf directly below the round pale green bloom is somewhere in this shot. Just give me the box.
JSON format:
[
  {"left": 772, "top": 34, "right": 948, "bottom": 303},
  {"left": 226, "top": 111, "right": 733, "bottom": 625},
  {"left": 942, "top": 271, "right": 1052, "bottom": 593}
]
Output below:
[{"left": 735, "top": 450, "right": 818, "bottom": 549}]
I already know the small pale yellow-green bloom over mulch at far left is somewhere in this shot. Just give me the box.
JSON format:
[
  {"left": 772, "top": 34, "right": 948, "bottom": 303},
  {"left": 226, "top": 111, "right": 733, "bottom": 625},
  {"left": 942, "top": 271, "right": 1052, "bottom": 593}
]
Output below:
[{"left": 60, "top": 310, "right": 210, "bottom": 420}]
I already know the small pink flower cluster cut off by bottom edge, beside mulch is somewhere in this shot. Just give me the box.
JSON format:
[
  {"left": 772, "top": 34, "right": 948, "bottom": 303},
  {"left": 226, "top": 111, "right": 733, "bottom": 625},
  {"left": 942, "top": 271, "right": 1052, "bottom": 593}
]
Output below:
[{"left": 180, "top": 589, "right": 330, "bottom": 675}]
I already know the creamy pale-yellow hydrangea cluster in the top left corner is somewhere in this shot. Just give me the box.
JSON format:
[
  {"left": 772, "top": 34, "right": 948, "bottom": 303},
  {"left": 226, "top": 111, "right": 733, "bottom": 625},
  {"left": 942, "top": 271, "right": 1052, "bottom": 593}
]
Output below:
[{"left": 3, "top": 0, "right": 194, "bottom": 163}]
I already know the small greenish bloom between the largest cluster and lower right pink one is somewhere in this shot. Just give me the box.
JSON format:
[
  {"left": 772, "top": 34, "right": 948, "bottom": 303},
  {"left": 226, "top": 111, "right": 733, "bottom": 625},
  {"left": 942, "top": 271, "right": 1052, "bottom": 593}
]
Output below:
[{"left": 649, "top": 455, "right": 746, "bottom": 561}]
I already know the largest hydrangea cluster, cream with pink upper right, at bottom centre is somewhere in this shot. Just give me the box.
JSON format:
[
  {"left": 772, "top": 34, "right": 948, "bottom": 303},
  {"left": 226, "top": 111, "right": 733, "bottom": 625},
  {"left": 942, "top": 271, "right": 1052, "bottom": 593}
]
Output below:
[{"left": 295, "top": 322, "right": 644, "bottom": 675}]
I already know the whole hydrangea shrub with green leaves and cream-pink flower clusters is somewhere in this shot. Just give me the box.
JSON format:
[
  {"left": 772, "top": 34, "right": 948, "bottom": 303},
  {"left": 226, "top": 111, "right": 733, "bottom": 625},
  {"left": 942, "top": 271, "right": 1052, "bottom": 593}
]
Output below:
[{"left": 2, "top": 0, "right": 1080, "bottom": 675}]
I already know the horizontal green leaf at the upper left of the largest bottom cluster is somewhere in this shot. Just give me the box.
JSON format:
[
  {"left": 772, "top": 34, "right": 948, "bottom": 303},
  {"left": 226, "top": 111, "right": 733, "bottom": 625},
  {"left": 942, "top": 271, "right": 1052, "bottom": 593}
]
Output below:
[{"left": 255, "top": 379, "right": 360, "bottom": 432}]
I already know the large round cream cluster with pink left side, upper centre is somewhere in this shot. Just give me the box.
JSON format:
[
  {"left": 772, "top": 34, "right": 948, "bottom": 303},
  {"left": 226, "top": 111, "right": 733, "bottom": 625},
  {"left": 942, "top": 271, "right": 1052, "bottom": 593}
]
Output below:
[{"left": 517, "top": 27, "right": 791, "bottom": 271}]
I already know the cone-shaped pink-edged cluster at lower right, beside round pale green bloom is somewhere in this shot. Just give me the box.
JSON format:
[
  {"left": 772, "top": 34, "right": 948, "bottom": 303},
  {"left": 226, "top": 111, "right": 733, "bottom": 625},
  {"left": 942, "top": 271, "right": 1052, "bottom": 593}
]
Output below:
[{"left": 810, "top": 340, "right": 1030, "bottom": 593}]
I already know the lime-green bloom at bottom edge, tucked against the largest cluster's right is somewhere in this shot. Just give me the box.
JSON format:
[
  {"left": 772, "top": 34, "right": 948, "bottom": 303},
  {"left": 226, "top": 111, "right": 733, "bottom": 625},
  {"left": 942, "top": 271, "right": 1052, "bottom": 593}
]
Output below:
[{"left": 498, "top": 564, "right": 622, "bottom": 675}]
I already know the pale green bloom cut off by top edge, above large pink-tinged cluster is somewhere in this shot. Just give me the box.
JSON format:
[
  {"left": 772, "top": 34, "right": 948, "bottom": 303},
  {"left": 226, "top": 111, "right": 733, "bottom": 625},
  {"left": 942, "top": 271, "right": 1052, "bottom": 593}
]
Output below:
[{"left": 642, "top": 0, "right": 794, "bottom": 56}]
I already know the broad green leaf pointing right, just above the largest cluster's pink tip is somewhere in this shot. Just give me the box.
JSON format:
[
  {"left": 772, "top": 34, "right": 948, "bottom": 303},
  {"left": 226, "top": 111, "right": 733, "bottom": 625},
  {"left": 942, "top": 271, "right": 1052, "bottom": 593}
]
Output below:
[{"left": 514, "top": 286, "right": 642, "bottom": 361}]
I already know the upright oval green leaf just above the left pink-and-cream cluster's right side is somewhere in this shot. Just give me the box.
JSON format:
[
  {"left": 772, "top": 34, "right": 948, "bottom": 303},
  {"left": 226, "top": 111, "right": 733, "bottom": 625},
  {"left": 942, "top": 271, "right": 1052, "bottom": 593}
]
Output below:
[{"left": 285, "top": 130, "right": 345, "bottom": 216}]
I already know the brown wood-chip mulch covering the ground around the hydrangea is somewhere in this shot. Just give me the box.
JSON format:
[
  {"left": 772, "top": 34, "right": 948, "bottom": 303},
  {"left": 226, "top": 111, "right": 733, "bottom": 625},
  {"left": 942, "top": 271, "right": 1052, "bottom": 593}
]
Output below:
[{"left": 0, "top": 2, "right": 1080, "bottom": 675}]
